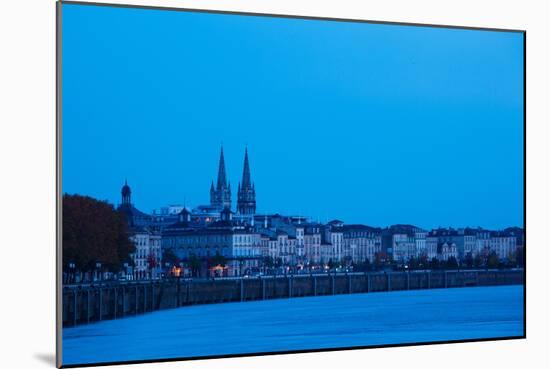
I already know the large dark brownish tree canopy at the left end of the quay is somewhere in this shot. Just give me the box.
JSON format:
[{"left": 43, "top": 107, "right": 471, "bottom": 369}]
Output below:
[{"left": 63, "top": 194, "right": 135, "bottom": 271}]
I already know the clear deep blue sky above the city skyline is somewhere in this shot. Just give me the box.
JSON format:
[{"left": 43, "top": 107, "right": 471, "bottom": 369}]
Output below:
[{"left": 62, "top": 4, "right": 524, "bottom": 228}]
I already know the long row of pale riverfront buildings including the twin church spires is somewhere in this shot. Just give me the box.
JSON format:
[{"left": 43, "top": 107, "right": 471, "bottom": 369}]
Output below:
[{"left": 118, "top": 148, "right": 524, "bottom": 279}]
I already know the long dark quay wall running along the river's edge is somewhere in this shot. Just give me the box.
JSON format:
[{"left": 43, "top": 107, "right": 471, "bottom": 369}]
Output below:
[{"left": 63, "top": 269, "right": 524, "bottom": 327}]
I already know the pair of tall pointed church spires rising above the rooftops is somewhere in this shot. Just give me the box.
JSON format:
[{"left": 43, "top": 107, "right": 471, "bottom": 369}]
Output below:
[{"left": 210, "top": 146, "right": 256, "bottom": 215}]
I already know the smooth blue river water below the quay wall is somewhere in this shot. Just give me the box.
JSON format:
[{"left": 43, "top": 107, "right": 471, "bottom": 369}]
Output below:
[{"left": 63, "top": 286, "right": 524, "bottom": 365}]
